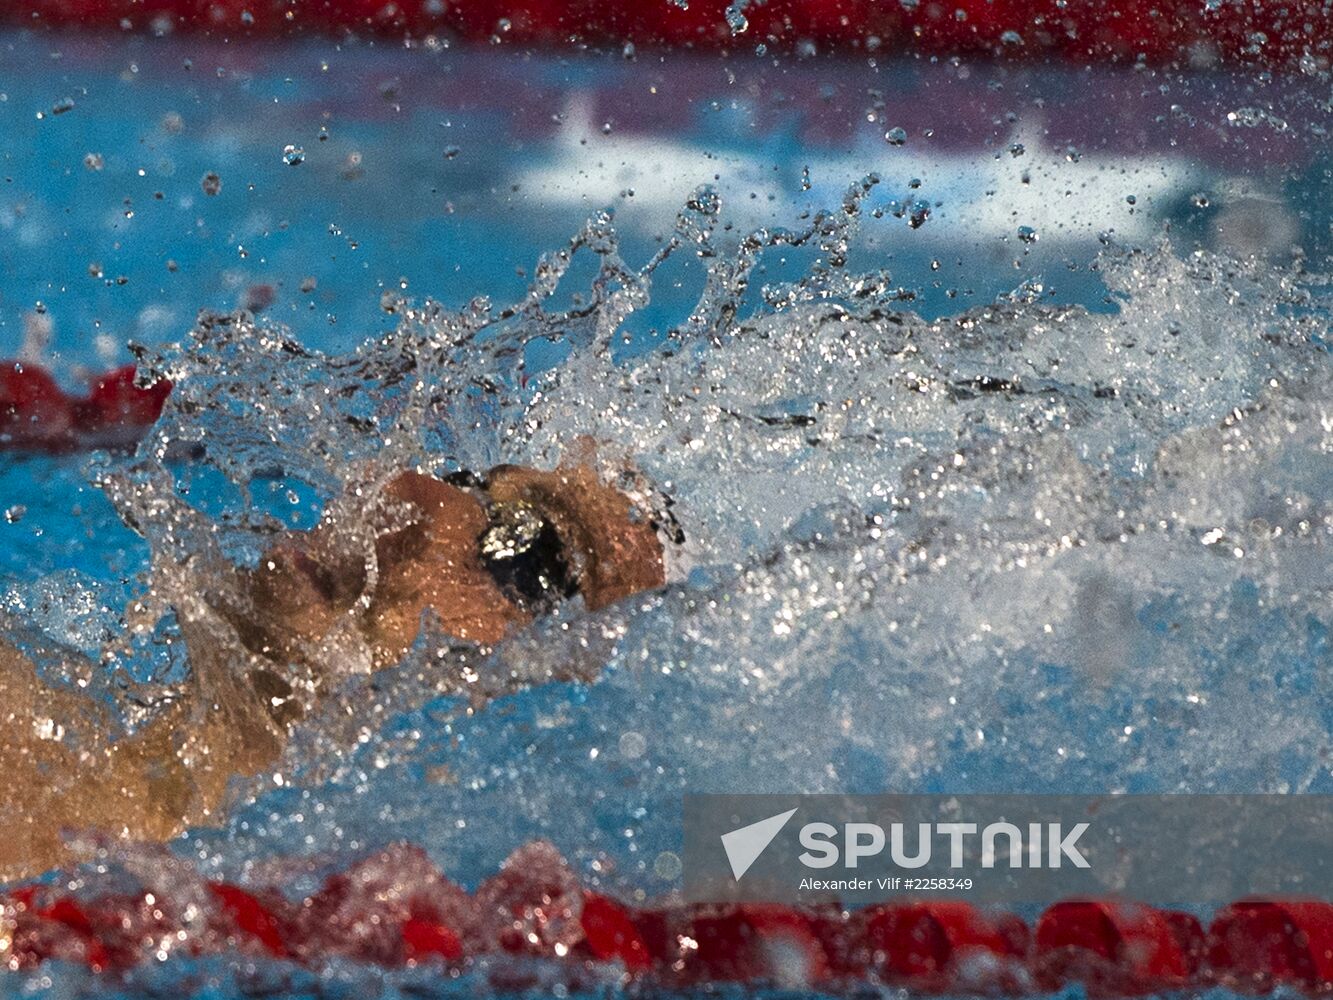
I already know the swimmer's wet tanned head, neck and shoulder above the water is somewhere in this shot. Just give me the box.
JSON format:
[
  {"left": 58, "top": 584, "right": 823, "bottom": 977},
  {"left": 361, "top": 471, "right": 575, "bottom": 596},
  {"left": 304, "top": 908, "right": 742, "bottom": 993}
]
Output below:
[{"left": 0, "top": 465, "right": 665, "bottom": 881}]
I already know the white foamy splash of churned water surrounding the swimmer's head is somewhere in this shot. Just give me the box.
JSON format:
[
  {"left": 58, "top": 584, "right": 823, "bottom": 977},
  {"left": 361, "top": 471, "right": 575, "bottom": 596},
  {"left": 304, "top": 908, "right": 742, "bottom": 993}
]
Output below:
[{"left": 2, "top": 177, "right": 1333, "bottom": 986}]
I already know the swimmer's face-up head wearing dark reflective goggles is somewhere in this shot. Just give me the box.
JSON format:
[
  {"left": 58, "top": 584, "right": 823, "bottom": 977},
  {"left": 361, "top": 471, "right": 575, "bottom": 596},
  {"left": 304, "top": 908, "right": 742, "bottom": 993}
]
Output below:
[{"left": 229, "top": 465, "right": 665, "bottom": 667}]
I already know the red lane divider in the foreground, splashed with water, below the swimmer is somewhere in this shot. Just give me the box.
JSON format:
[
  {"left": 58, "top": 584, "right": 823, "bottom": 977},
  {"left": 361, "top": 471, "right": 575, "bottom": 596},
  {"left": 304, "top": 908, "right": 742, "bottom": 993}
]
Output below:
[{"left": 0, "top": 843, "right": 1333, "bottom": 997}]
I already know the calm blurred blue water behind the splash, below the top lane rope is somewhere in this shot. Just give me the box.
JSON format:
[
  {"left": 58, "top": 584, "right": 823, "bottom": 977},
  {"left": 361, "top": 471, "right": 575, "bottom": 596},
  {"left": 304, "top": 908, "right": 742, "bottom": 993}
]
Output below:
[{"left": 0, "top": 33, "right": 1330, "bottom": 364}]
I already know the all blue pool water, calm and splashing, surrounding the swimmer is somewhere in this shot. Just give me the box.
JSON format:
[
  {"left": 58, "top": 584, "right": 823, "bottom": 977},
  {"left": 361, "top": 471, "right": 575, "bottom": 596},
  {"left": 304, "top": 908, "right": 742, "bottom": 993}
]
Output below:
[{"left": 0, "top": 27, "right": 1333, "bottom": 996}]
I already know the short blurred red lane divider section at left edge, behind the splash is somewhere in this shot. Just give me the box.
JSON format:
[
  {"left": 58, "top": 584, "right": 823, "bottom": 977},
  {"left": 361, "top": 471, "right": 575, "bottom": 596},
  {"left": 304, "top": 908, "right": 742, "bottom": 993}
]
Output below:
[{"left": 0, "top": 361, "right": 172, "bottom": 453}]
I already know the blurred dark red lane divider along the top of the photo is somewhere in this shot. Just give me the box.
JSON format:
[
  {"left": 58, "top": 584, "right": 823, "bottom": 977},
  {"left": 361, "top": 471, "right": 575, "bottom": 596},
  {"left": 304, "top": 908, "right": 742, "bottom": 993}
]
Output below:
[{"left": 0, "top": 0, "right": 1333, "bottom": 65}]
